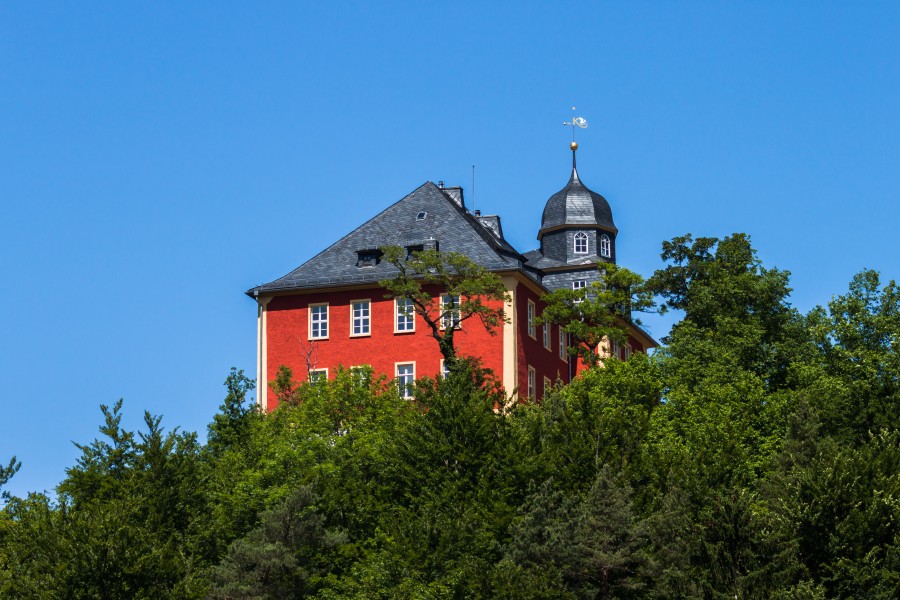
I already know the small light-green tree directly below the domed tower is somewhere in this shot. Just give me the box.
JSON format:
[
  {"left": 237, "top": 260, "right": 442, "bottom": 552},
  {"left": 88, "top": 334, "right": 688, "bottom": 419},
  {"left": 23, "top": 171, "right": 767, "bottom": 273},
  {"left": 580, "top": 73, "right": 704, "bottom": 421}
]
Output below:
[{"left": 537, "top": 263, "right": 653, "bottom": 365}]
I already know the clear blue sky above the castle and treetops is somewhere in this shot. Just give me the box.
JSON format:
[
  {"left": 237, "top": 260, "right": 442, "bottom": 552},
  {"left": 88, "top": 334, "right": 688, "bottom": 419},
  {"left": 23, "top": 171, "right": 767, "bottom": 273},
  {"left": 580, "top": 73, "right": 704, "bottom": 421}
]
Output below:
[{"left": 0, "top": 2, "right": 900, "bottom": 494}]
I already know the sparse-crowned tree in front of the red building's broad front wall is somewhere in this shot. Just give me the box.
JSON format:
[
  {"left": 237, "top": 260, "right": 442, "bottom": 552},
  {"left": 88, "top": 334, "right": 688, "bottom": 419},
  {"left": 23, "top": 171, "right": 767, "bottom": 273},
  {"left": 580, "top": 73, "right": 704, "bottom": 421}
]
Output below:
[{"left": 379, "top": 246, "right": 510, "bottom": 368}]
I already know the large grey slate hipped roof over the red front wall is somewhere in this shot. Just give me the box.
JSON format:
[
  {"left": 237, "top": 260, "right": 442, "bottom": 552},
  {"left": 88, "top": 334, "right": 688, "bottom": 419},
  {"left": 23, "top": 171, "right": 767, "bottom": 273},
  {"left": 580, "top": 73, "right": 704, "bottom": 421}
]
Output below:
[{"left": 247, "top": 181, "right": 528, "bottom": 296}]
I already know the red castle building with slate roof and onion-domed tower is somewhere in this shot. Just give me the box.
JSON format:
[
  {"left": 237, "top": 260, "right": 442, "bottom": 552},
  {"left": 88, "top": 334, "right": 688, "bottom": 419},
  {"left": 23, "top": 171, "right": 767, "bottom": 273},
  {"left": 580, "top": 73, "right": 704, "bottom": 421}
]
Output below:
[{"left": 247, "top": 142, "right": 656, "bottom": 410}]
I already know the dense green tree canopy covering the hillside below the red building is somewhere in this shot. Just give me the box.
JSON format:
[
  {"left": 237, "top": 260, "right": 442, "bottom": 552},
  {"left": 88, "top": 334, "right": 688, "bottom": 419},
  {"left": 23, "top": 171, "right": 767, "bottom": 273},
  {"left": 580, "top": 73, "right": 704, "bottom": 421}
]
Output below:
[{"left": 0, "top": 235, "right": 900, "bottom": 599}]
